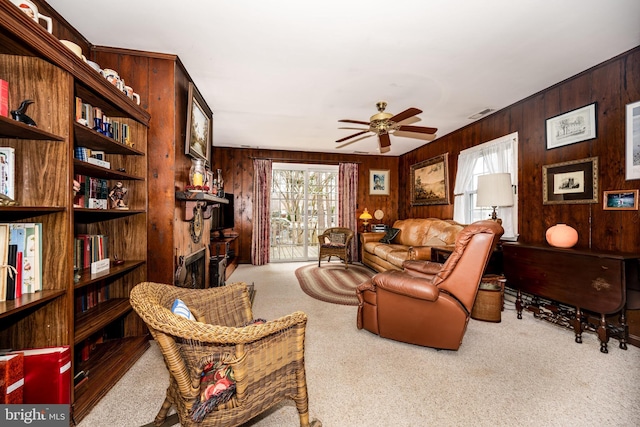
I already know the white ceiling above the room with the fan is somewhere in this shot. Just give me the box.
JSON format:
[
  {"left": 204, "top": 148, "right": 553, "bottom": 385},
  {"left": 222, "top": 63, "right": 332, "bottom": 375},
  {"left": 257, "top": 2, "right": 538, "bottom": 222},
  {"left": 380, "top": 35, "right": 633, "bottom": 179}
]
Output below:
[{"left": 48, "top": 0, "right": 640, "bottom": 156}]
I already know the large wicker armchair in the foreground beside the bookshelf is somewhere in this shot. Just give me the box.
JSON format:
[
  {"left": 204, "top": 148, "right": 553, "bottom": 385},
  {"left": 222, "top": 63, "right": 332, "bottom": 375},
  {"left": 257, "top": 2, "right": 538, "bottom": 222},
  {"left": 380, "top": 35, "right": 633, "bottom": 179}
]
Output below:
[{"left": 130, "top": 282, "right": 322, "bottom": 427}]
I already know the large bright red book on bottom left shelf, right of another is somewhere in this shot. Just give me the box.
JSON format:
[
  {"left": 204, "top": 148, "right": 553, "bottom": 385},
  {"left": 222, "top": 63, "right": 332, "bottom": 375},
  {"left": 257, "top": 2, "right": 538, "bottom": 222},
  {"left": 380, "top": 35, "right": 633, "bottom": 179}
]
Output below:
[{"left": 10, "top": 346, "right": 71, "bottom": 405}]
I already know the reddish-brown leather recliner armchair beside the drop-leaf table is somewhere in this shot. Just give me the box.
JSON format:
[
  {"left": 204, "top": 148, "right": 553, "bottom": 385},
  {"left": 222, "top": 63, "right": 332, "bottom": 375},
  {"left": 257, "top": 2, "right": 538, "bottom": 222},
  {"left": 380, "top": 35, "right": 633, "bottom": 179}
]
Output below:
[{"left": 356, "top": 221, "right": 503, "bottom": 350}]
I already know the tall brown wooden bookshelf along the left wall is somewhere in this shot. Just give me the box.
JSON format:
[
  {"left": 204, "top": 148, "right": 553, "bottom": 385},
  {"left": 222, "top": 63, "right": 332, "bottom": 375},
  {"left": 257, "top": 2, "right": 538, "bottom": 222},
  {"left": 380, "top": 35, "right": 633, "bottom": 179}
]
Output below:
[{"left": 0, "top": 1, "right": 150, "bottom": 422}]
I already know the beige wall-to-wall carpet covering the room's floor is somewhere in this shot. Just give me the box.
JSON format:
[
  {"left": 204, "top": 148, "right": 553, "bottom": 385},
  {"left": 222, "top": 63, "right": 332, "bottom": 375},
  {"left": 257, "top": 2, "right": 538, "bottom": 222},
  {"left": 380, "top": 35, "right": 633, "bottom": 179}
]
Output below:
[{"left": 80, "top": 263, "right": 640, "bottom": 427}]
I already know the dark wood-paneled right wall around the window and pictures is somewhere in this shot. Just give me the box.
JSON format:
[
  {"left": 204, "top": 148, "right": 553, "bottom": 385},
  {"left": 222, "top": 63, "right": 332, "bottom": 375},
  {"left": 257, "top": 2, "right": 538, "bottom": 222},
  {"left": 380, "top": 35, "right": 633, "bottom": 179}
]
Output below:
[{"left": 396, "top": 47, "right": 640, "bottom": 252}]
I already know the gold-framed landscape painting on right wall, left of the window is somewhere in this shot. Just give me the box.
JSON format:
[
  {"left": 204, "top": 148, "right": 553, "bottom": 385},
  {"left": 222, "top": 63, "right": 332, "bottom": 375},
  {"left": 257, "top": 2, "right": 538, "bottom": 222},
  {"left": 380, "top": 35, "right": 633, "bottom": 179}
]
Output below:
[{"left": 411, "top": 153, "right": 449, "bottom": 206}]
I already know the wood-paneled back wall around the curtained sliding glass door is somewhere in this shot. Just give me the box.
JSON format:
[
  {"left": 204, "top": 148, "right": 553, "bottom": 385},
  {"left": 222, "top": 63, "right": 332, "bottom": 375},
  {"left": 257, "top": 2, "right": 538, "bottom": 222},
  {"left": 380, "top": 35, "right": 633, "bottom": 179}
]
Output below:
[{"left": 213, "top": 148, "right": 399, "bottom": 263}]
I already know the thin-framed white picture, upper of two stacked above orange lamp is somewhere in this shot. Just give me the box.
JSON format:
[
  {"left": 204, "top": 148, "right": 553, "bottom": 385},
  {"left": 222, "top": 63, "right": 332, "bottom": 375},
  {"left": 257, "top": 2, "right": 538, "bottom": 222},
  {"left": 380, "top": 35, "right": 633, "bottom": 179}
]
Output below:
[{"left": 547, "top": 102, "right": 596, "bottom": 150}]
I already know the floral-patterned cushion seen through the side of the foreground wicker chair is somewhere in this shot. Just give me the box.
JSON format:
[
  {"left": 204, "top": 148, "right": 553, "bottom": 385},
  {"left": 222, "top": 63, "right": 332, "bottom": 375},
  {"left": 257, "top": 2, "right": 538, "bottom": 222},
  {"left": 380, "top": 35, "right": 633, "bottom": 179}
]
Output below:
[{"left": 190, "top": 360, "right": 236, "bottom": 422}]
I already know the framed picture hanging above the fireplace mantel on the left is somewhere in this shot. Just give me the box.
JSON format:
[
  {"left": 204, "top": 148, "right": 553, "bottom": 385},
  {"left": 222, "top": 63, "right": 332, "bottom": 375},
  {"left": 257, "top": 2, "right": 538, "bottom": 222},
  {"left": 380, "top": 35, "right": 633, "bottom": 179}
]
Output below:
[{"left": 184, "top": 82, "right": 213, "bottom": 167}]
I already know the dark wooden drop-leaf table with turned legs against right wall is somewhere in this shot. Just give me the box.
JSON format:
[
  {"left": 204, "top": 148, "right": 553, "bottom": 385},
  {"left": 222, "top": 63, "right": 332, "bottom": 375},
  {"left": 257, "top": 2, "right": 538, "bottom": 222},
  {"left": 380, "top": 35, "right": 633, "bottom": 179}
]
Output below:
[{"left": 502, "top": 243, "right": 640, "bottom": 353}]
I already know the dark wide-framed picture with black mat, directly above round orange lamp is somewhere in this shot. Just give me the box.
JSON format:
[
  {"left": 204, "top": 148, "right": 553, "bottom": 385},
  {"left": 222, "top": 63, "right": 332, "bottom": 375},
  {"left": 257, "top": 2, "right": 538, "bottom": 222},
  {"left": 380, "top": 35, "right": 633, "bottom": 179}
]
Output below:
[{"left": 542, "top": 157, "right": 598, "bottom": 205}]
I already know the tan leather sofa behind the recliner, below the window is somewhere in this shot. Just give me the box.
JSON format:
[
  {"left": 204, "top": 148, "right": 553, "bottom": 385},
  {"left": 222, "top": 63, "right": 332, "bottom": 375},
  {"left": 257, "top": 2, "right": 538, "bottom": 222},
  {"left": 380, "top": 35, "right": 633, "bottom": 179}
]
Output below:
[{"left": 360, "top": 218, "right": 464, "bottom": 272}]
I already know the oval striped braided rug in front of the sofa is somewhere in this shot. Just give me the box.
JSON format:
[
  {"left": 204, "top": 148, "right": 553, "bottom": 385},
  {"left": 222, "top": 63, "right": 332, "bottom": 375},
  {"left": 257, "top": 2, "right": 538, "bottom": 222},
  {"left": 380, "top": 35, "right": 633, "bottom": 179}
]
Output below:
[{"left": 296, "top": 263, "right": 375, "bottom": 305}]
